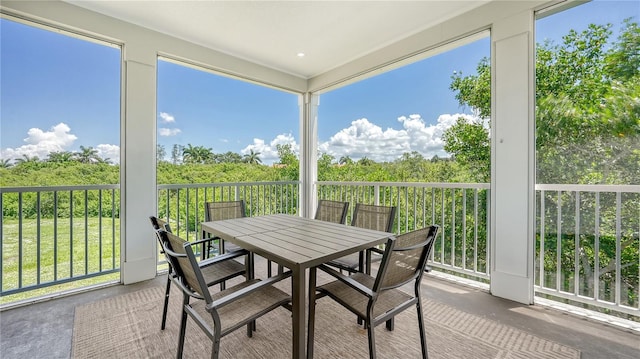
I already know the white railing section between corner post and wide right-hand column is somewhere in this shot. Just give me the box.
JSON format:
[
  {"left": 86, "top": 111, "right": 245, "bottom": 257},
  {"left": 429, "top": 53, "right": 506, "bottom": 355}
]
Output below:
[{"left": 316, "top": 181, "right": 491, "bottom": 281}]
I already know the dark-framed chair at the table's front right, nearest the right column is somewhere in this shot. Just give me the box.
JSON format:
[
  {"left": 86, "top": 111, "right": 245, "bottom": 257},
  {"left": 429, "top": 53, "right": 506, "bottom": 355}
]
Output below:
[{"left": 307, "top": 225, "right": 439, "bottom": 359}]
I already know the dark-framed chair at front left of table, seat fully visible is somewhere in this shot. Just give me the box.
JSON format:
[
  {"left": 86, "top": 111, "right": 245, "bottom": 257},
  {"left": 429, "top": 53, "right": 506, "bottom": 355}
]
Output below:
[{"left": 158, "top": 230, "right": 291, "bottom": 359}]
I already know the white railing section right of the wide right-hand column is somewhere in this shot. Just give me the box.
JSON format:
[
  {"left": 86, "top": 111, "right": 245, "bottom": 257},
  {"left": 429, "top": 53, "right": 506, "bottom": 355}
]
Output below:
[{"left": 535, "top": 184, "right": 640, "bottom": 317}]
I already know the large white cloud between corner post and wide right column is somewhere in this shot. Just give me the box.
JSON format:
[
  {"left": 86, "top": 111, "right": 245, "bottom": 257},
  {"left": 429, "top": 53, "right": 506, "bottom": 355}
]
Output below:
[{"left": 318, "top": 114, "right": 475, "bottom": 162}]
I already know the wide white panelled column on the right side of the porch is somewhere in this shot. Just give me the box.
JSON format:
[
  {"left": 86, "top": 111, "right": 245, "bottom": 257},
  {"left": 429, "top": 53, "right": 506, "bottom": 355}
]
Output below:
[{"left": 491, "top": 11, "right": 535, "bottom": 304}]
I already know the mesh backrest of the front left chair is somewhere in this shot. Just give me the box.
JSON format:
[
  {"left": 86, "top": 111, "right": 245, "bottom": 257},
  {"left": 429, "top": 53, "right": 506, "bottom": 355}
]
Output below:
[{"left": 157, "top": 229, "right": 212, "bottom": 303}]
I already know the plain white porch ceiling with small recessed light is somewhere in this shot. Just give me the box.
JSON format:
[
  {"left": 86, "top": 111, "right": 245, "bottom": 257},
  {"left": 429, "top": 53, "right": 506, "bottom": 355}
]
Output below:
[{"left": 64, "top": 0, "right": 491, "bottom": 79}]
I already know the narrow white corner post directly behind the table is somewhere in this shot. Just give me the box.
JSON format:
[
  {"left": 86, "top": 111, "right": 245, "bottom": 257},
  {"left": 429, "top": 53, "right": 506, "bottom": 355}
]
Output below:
[{"left": 298, "top": 92, "right": 320, "bottom": 217}]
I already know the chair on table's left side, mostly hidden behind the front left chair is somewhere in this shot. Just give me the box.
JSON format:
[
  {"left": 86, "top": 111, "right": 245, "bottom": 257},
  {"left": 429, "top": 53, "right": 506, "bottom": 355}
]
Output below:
[{"left": 149, "top": 216, "right": 248, "bottom": 330}]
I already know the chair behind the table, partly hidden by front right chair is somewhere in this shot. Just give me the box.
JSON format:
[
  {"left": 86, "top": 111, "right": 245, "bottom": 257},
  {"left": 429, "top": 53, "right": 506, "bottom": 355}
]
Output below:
[{"left": 327, "top": 203, "right": 396, "bottom": 274}]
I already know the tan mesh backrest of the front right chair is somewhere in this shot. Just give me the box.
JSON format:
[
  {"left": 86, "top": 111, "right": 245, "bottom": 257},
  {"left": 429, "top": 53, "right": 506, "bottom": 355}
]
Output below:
[{"left": 373, "top": 225, "right": 439, "bottom": 292}]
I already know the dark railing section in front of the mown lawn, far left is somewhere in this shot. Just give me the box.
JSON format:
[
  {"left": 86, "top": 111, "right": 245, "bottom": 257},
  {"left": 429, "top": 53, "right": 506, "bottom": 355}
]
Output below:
[{"left": 0, "top": 185, "right": 120, "bottom": 296}]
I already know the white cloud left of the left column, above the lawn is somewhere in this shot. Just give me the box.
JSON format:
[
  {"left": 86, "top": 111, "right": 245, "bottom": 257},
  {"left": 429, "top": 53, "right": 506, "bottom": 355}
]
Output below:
[{"left": 0, "top": 123, "right": 78, "bottom": 160}]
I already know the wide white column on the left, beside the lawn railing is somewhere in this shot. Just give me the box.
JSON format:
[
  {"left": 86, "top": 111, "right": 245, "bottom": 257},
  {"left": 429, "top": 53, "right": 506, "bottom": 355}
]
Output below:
[{"left": 120, "top": 43, "right": 158, "bottom": 284}]
